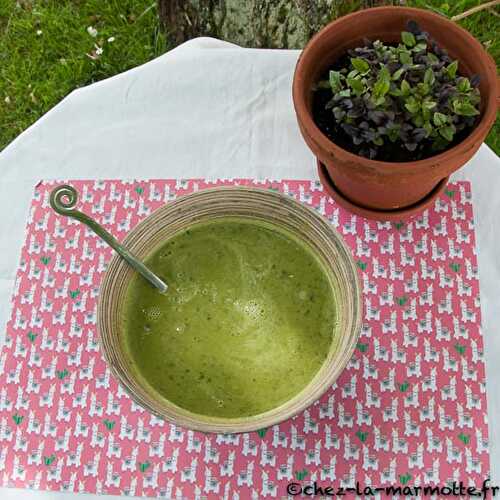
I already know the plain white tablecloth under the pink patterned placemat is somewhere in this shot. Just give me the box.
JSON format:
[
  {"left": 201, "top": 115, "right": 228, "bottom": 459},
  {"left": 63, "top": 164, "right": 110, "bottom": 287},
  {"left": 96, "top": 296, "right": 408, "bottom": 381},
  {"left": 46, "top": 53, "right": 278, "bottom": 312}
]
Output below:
[{"left": 0, "top": 38, "right": 500, "bottom": 500}]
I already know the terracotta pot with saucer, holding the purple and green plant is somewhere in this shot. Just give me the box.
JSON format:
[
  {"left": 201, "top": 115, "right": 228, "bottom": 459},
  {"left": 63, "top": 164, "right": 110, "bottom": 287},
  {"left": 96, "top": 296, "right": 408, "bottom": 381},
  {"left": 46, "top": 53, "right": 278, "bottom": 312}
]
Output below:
[{"left": 293, "top": 7, "right": 498, "bottom": 215}]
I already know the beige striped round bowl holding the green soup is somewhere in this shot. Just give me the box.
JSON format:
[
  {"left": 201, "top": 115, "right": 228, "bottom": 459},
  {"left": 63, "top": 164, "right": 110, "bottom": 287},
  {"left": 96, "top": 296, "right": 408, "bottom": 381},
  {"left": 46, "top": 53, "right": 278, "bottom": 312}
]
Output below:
[{"left": 97, "top": 187, "right": 362, "bottom": 433}]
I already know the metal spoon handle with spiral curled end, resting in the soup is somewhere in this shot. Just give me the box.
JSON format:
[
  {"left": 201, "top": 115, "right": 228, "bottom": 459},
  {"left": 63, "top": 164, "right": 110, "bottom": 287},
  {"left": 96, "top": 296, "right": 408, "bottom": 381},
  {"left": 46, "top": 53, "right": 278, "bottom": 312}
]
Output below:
[{"left": 50, "top": 184, "right": 168, "bottom": 293}]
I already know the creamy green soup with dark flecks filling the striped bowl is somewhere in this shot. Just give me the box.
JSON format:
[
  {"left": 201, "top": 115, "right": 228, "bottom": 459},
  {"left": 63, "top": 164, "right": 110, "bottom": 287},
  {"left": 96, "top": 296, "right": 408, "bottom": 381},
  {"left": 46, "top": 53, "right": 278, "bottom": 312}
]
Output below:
[{"left": 123, "top": 218, "right": 335, "bottom": 418}]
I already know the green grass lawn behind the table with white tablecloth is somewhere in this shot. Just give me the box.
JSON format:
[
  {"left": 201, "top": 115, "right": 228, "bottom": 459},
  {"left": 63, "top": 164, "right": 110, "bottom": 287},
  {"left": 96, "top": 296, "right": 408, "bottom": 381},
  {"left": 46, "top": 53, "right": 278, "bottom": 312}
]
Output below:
[{"left": 0, "top": 0, "right": 500, "bottom": 155}]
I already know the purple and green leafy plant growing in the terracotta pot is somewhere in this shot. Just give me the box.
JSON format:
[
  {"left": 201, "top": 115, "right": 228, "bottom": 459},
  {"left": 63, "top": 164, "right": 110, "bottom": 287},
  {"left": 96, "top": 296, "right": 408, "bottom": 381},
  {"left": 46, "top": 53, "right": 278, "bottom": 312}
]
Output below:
[{"left": 316, "top": 21, "right": 480, "bottom": 159}]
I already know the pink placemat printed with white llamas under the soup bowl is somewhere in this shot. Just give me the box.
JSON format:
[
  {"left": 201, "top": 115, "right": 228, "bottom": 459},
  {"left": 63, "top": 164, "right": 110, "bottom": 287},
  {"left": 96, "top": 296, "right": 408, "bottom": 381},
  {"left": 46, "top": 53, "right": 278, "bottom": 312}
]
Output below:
[{"left": 0, "top": 179, "right": 489, "bottom": 499}]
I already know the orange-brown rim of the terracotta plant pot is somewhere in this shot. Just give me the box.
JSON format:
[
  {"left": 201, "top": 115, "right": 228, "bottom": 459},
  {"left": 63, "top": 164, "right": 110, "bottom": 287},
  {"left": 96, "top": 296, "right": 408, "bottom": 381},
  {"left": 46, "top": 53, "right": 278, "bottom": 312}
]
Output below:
[{"left": 292, "top": 6, "right": 499, "bottom": 173}]
